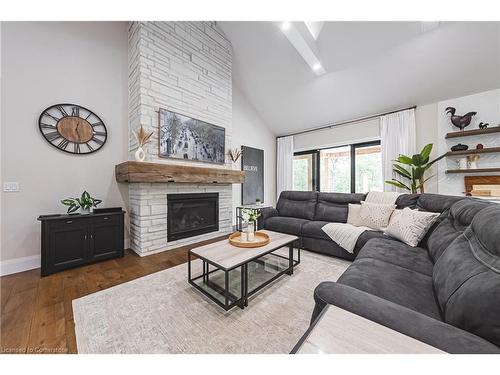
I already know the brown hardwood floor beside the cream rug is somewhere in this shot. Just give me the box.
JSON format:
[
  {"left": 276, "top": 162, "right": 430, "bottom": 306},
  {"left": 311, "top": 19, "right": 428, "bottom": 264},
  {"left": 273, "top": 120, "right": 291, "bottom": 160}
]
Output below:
[{"left": 0, "top": 236, "right": 226, "bottom": 353}]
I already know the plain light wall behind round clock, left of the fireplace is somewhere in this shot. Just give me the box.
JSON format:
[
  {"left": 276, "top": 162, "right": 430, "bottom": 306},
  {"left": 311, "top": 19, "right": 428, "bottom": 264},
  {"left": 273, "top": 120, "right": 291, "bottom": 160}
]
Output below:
[{"left": 0, "top": 22, "right": 128, "bottom": 272}]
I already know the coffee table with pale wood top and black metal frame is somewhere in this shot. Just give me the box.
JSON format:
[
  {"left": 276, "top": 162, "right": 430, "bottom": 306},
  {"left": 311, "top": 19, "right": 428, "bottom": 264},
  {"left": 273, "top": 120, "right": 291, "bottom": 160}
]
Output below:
[{"left": 188, "top": 230, "right": 300, "bottom": 310}]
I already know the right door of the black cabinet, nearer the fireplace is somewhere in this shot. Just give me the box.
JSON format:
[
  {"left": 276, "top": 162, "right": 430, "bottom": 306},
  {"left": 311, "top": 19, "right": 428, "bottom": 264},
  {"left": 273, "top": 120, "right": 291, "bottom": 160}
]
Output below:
[{"left": 90, "top": 216, "right": 123, "bottom": 260}]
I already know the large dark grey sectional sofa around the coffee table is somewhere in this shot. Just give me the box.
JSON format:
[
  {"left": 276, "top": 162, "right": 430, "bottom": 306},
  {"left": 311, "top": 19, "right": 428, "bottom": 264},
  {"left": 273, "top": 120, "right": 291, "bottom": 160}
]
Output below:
[{"left": 262, "top": 191, "right": 500, "bottom": 353}]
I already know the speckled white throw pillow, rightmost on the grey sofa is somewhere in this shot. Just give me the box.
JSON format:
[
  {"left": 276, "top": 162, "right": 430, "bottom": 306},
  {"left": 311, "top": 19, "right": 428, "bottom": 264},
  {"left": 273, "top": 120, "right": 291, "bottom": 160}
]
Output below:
[{"left": 385, "top": 207, "right": 439, "bottom": 247}]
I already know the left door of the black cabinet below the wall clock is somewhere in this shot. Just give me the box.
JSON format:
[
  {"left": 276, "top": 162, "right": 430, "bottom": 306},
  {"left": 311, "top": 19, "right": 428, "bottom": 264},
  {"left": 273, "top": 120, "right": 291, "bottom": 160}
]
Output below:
[{"left": 48, "top": 220, "right": 88, "bottom": 272}]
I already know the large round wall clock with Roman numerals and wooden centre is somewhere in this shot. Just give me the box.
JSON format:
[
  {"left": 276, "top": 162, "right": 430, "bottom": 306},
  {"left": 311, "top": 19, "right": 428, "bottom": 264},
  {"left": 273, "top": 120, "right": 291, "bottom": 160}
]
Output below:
[{"left": 38, "top": 104, "right": 108, "bottom": 154}]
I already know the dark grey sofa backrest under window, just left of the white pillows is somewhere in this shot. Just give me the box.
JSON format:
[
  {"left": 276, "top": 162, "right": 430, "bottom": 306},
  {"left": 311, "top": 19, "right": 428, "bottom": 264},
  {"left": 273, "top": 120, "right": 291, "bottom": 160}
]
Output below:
[{"left": 314, "top": 193, "right": 366, "bottom": 223}]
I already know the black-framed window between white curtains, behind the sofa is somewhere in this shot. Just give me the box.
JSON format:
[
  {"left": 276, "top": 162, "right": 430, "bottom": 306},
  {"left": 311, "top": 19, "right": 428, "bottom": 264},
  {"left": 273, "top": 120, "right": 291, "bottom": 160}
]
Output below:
[{"left": 293, "top": 141, "right": 383, "bottom": 193}]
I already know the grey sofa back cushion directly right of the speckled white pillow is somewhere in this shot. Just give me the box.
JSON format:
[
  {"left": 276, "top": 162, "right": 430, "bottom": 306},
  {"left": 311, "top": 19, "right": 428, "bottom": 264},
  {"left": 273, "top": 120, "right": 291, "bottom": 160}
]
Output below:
[{"left": 426, "top": 200, "right": 492, "bottom": 262}]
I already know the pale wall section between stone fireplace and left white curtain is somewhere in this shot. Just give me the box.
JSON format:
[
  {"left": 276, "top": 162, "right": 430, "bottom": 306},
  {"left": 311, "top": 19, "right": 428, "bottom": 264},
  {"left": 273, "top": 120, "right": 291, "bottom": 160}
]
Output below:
[{"left": 232, "top": 83, "right": 276, "bottom": 223}]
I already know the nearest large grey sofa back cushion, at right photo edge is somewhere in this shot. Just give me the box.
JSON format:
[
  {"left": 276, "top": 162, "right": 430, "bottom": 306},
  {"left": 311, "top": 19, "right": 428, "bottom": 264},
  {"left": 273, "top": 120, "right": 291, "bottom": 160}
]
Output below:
[{"left": 433, "top": 204, "right": 500, "bottom": 346}]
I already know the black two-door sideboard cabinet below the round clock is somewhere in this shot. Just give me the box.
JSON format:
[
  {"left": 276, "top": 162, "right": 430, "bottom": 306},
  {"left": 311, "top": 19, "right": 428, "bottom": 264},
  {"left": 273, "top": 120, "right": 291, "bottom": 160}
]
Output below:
[{"left": 38, "top": 209, "right": 125, "bottom": 276}]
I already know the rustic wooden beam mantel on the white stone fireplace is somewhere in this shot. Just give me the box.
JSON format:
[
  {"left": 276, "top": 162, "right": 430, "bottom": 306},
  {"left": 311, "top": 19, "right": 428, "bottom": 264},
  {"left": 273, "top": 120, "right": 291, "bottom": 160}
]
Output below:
[{"left": 115, "top": 161, "right": 245, "bottom": 184}]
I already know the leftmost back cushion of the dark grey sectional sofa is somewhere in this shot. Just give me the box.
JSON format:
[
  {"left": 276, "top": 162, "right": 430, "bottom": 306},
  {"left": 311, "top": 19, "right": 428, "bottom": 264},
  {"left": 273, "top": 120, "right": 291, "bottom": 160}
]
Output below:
[{"left": 276, "top": 191, "right": 318, "bottom": 220}]
